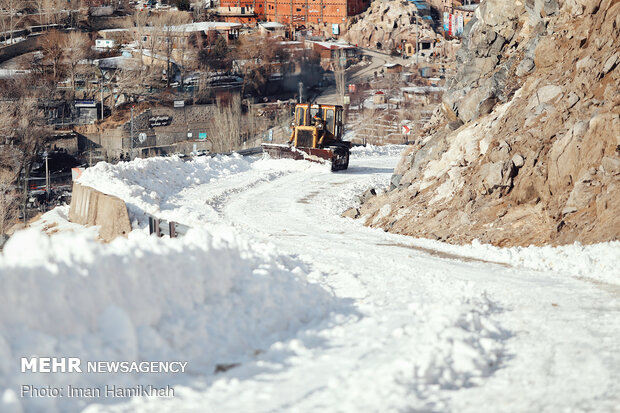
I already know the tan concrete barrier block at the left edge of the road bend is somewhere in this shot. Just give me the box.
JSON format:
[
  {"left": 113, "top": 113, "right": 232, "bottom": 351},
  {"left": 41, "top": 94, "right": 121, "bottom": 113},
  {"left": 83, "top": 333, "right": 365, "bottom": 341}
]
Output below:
[{"left": 69, "top": 183, "right": 131, "bottom": 242}]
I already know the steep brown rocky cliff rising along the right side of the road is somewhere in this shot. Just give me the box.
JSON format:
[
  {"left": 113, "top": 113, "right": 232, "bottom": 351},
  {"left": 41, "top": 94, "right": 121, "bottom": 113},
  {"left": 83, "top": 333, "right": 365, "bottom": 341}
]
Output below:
[{"left": 361, "top": 0, "right": 620, "bottom": 246}]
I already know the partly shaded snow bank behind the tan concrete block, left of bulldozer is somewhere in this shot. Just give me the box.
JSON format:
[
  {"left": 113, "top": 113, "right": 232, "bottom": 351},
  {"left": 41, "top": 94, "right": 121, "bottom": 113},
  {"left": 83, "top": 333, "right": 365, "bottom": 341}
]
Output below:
[{"left": 78, "top": 153, "right": 329, "bottom": 228}]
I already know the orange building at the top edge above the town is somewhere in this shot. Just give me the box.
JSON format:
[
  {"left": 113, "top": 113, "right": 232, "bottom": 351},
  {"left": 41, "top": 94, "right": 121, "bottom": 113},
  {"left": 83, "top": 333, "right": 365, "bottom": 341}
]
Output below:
[{"left": 220, "top": 0, "right": 370, "bottom": 28}]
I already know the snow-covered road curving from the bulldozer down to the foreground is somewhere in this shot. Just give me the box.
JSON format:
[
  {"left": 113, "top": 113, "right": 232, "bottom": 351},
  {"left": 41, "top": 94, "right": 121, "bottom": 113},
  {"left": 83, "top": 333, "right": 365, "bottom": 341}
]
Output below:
[{"left": 213, "top": 152, "right": 620, "bottom": 412}]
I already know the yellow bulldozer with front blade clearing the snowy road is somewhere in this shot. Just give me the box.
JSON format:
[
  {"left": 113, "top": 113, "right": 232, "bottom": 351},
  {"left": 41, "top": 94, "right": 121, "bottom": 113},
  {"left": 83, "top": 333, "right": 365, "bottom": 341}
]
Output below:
[{"left": 263, "top": 103, "right": 351, "bottom": 171}]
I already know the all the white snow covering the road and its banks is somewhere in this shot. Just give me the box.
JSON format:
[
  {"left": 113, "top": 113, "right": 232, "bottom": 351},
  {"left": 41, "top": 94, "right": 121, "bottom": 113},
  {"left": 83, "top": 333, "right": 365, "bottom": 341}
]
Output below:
[{"left": 0, "top": 143, "right": 620, "bottom": 413}]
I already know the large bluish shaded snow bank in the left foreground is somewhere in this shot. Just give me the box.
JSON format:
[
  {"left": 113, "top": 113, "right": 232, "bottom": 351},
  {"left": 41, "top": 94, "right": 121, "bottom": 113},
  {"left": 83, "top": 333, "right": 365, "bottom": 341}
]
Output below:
[{"left": 0, "top": 227, "right": 334, "bottom": 412}]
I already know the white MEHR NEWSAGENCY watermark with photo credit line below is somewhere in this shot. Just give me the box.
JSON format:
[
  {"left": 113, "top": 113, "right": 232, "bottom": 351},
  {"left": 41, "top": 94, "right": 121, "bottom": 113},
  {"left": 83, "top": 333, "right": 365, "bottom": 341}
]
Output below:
[{"left": 20, "top": 357, "right": 187, "bottom": 398}]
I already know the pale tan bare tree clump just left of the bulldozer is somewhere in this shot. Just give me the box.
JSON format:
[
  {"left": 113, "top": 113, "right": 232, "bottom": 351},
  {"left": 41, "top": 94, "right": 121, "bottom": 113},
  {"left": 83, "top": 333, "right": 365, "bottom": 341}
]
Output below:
[{"left": 210, "top": 95, "right": 241, "bottom": 152}]
